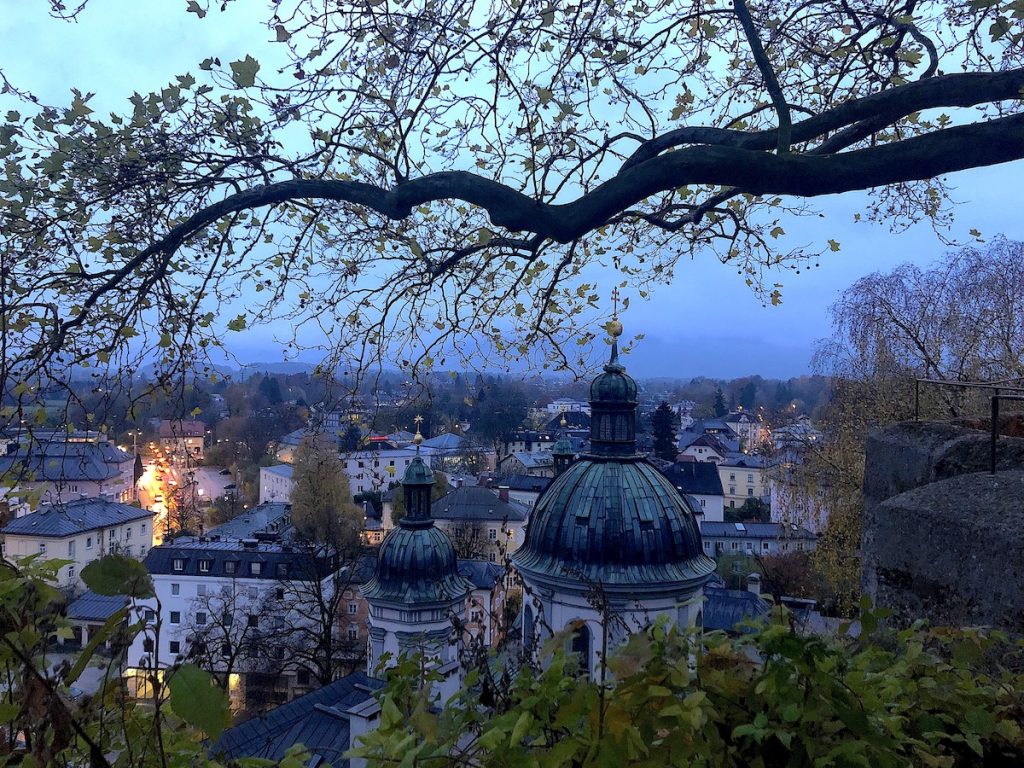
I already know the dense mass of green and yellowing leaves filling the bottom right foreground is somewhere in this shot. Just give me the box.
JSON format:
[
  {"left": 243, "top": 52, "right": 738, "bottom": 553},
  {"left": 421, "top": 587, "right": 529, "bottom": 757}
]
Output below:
[{"left": 356, "top": 610, "right": 1024, "bottom": 768}]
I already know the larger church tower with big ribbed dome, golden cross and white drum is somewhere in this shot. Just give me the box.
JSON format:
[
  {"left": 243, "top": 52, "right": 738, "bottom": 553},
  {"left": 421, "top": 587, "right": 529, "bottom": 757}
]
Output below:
[{"left": 512, "top": 319, "right": 715, "bottom": 676}]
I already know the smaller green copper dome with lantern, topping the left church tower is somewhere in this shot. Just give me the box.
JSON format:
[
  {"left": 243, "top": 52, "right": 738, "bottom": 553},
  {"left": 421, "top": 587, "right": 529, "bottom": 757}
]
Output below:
[{"left": 361, "top": 455, "right": 473, "bottom": 605}]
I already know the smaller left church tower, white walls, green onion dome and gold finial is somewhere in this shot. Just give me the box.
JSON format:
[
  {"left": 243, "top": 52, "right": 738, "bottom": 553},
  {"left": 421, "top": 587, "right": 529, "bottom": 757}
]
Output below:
[{"left": 361, "top": 428, "right": 473, "bottom": 688}]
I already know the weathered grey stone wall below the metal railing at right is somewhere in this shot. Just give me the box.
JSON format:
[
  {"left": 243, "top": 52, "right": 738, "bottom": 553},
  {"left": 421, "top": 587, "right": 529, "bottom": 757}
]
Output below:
[{"left": 862, "top": 422, "right": 1024, "bottom": 630}]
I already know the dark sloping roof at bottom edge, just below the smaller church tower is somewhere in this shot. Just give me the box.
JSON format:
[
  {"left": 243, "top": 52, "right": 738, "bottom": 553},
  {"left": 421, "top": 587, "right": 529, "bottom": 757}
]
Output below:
[{"left": 210, "top": 672, "right": 383, "bottom": 768}]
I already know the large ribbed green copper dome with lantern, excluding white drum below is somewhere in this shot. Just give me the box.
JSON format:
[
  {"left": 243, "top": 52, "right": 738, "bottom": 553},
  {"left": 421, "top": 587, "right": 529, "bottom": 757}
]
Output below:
[{"left": 513, "top": 329, "right": 715, "bottom": 588}]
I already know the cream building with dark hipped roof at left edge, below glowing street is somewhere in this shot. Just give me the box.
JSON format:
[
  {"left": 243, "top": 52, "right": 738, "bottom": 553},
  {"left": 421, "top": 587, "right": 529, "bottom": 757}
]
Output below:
[{"left": 0, "top": 499, "right": 154, "bottom": 592}]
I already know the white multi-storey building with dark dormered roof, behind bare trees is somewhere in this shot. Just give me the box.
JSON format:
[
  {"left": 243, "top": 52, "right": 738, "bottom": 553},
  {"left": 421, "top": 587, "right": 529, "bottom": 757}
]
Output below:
[{"left": 125, "top": 504, "right": 336, "bottom": 707}]
